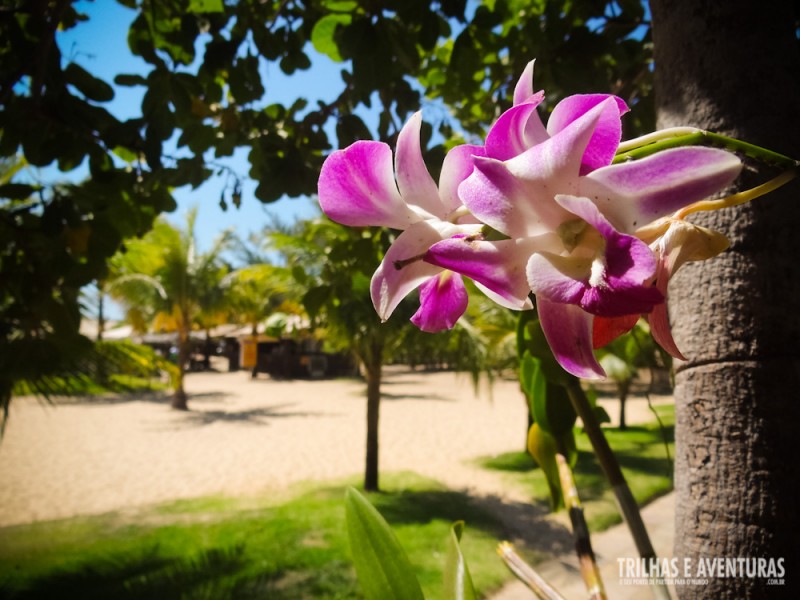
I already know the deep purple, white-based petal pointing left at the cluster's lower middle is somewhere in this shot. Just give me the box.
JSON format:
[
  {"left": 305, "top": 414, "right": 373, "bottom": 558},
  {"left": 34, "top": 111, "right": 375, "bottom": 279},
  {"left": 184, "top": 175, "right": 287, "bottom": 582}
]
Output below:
[{"left": 425, "top": 236, "right": 556, "bottom": 310}]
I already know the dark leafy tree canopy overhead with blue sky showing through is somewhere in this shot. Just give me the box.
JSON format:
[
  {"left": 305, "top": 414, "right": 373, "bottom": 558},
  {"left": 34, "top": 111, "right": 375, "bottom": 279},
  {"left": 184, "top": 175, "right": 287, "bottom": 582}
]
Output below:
[{"left": 0, "top": 0, "right": 653, "bottom": 420}]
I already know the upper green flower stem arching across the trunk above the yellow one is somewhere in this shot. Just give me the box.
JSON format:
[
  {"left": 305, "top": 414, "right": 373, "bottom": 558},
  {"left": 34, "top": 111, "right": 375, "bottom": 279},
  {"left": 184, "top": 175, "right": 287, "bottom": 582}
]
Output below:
[{"left": 613, "top": 127, "right": 800, "bottom": 169}]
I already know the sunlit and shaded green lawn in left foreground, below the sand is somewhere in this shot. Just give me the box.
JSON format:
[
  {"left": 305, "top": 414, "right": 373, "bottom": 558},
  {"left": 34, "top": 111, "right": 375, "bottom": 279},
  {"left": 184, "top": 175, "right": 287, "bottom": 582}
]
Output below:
[{"left": 0, "top": 474, "right": 524, "bottom": 600}]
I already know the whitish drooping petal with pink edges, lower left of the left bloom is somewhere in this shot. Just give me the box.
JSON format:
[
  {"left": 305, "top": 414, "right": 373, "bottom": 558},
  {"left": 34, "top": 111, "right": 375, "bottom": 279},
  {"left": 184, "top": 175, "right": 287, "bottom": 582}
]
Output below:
[{"left": 370, "top": 221, "right": 453, "bottom": 321}]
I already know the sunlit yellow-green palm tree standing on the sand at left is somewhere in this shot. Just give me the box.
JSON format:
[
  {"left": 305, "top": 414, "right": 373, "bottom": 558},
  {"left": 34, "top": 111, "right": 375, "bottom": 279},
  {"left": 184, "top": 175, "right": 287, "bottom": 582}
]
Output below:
[{"left": 109, "top": 208, "right": 230, "bottom": 410}]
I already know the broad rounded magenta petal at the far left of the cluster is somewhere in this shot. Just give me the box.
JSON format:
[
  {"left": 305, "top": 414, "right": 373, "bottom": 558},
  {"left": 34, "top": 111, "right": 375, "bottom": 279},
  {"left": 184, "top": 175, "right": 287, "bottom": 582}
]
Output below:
[{"left": 318, "top": 141, "right": 420, "bottom": 229}]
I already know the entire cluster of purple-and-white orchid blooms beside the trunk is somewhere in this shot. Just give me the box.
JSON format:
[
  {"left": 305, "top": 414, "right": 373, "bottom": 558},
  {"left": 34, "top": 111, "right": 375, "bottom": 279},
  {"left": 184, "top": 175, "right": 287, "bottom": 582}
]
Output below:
[{"left": 319, "top": 62, "right": 742, "bottom": 379}]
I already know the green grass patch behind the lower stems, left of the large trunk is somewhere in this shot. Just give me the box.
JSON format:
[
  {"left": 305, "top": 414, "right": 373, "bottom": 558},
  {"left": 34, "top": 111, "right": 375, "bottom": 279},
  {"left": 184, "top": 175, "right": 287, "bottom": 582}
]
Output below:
[{"left": 479, "top": 405, "right": 675, "bottom": 531}]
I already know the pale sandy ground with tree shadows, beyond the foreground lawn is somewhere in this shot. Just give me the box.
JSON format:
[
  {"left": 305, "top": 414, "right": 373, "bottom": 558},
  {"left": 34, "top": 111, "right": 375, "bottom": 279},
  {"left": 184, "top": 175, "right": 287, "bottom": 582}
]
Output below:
[{"left": 0, "top": 369, "right": 669, "bottom": 526}]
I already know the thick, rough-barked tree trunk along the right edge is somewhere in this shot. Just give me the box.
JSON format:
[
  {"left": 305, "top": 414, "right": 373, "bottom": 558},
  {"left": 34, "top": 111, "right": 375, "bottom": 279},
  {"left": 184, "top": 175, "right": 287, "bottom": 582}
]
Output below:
[{"left": 651, "top": 0, "right": 800, "bottom": 599}]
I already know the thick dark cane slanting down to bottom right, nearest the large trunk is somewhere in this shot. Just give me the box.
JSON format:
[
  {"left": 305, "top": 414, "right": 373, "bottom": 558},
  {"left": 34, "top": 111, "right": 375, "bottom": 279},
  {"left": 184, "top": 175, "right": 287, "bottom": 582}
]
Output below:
[{"left": 567, "top": 378, "right": 670, "bottom": 600}]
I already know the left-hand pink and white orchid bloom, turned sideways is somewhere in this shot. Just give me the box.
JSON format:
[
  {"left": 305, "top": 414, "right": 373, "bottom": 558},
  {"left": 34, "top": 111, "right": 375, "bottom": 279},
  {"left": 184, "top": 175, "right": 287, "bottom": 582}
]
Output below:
[{"left": 319, "top": 113, "right": 532, "bottom": 332}]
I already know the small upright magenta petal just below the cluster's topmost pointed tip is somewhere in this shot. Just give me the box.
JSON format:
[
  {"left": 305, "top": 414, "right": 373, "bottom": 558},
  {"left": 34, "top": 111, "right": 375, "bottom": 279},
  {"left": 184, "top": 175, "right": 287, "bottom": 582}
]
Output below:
[{"left": 486, "top": 97, "right": 550, "bottom": 160}]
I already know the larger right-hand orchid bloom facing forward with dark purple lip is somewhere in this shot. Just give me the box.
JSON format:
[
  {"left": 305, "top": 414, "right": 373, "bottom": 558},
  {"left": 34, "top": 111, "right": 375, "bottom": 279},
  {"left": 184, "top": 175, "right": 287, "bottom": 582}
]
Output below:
[{"left": 444, "top": 68, "right": 741, "bottom": 378}]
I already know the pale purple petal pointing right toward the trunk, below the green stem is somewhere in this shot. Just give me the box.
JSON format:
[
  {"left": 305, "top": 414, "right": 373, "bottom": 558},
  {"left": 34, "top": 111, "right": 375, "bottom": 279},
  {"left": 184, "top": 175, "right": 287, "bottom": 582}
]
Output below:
[{"left": 578, "top": 147, "right": 742, "bottom": 233}]
